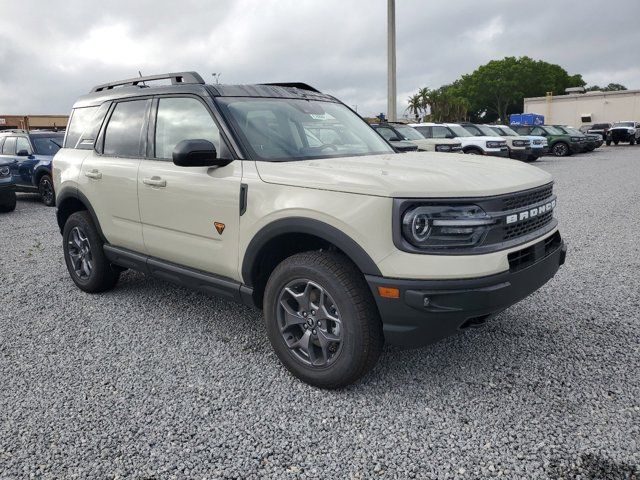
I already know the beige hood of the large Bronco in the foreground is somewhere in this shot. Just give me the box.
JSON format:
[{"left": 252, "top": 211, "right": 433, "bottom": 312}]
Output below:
[{"left": 256, "top": 152, "right": 553, "bottom": 198}]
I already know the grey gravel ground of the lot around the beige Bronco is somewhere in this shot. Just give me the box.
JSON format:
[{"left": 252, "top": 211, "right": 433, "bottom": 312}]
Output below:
[{"left": 0, "top": 146, "right": 640, "bottom": 479}]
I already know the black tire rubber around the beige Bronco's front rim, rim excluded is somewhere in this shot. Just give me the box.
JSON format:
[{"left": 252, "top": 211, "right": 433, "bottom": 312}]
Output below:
[{"left": 264, "top": 251, "right": 384, "bottom": 389}]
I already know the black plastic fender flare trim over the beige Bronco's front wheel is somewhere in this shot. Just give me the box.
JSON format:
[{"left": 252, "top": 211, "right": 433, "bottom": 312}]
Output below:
[{"left": 242, "top": 217, "right": 382, "bottom": 286}]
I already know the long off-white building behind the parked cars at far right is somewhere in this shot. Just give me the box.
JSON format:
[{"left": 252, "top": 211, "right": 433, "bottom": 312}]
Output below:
[{"left": 524, "top": 90, "right": 640, "bottom": 127}]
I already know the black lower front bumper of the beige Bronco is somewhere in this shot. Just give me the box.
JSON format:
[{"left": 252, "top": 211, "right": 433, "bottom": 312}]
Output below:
[{"left": 366, "top": 232, "right": 567, "bottom": 348}]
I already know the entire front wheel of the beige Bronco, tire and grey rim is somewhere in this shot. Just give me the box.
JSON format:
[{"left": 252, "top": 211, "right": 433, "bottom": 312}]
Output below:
[{"left": 264, "top": 252, "right": 384, "bottom": 389}]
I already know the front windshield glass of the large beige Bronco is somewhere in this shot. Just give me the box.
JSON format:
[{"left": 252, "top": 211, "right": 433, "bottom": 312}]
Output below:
[{"left": 218, "top": 97, "right": 395, "bottom": 161}]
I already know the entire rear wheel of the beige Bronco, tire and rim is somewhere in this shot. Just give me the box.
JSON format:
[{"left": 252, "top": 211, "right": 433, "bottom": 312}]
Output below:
[{"left": 62, "top": 211, "right": 120, "bottom": 293}]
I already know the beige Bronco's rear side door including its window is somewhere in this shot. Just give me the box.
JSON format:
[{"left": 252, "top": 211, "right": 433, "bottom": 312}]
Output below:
[{"left": 77, "top": 98, "right": 151, "bottom": 252}]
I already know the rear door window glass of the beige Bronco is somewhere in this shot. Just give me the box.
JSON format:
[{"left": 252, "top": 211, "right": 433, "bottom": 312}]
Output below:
[{"left": 103, "top": 100, "right": 149, "bottom": 157}]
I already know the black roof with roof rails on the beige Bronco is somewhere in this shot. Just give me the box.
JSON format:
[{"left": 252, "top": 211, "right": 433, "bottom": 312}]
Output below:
[{"left": 74, "top": 72, "right": 338, "bottom": 108}]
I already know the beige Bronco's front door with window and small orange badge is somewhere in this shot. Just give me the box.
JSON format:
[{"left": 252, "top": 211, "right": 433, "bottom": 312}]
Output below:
[{"left": 138, "top": 96, "right": 242, "bottom": 279}]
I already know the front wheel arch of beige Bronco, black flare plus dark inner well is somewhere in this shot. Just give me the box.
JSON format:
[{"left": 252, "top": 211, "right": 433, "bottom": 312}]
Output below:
[{"left": 242, "top": 217, "right": 382, "bottom": 307}]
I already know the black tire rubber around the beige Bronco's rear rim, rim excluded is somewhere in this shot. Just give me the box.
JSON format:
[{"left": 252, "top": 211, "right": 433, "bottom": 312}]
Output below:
[{"left": 62, "top": 210, "right": 120, "bottom": 293}]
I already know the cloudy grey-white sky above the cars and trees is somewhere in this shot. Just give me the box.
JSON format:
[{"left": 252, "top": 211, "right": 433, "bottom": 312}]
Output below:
[{"left": 0, "top": 0, "right": 640, "bottom": 115}]
